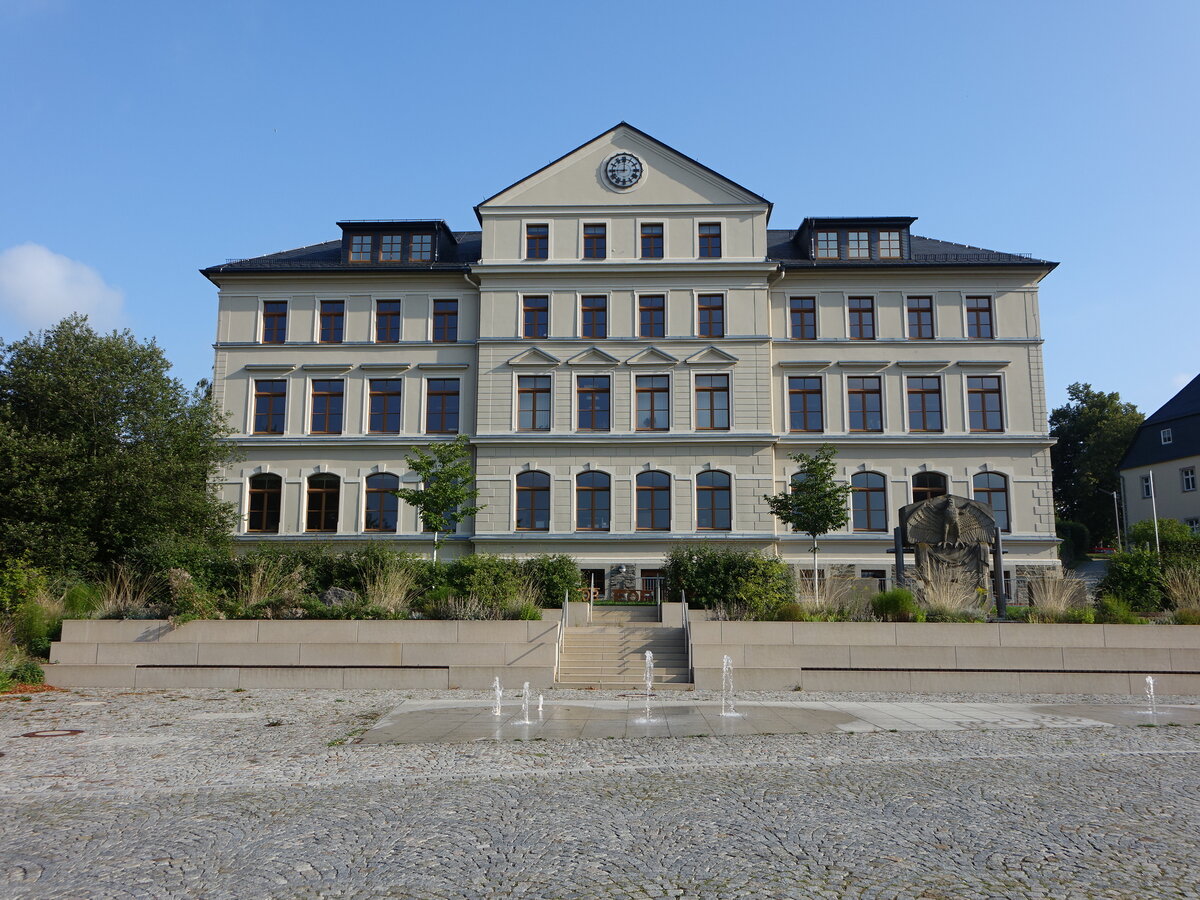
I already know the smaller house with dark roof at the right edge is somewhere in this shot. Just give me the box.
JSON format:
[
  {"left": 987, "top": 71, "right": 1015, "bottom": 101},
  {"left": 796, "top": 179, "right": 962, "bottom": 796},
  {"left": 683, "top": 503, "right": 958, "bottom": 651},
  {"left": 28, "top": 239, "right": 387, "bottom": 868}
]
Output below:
[{"left": 1118, "top": 376, "right": 1200, "bottom": 534}]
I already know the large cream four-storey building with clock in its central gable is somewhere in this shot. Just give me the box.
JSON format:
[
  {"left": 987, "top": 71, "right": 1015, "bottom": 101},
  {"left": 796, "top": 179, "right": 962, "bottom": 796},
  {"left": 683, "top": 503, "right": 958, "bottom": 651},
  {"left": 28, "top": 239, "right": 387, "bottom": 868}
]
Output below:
[{"left": 204, "top": 124, "right": 1057, "bottom": 595}]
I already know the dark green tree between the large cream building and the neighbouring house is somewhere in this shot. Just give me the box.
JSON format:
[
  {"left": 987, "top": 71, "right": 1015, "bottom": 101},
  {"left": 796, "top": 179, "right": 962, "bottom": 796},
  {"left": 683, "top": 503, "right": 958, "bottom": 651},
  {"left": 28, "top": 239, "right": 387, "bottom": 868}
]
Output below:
[{"left": 1050, "top": 382, "right": 1145, "bottom": 542}]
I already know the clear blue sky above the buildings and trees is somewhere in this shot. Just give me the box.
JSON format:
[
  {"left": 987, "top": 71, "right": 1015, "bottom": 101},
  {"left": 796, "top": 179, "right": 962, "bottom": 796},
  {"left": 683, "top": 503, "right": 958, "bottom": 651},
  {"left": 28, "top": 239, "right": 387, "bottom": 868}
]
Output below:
[{"left": 0, "top": 0, "right": 1200, "bottom": 413}]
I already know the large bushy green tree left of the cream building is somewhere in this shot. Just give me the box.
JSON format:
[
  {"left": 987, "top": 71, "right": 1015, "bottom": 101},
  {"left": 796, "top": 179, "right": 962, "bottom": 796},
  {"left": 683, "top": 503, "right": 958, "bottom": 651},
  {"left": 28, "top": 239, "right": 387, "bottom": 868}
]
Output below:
[{"left": 0, "top": 316, "right": 234, "bottom": 571}]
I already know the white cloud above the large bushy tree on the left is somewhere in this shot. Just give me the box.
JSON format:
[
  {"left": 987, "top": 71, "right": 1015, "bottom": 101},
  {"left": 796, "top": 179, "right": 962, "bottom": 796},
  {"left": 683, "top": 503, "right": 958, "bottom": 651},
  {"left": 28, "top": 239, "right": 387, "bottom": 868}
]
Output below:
[{"left": 0, "top": 244, "right": 125, "bottom": 340}]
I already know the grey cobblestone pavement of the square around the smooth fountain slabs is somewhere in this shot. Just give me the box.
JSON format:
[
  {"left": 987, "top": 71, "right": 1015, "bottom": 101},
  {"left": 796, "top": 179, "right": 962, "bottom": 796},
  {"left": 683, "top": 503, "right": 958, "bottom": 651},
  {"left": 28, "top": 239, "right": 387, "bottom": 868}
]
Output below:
[{"left": 0, "top": 690, "right": 1200, "bottom": 900}]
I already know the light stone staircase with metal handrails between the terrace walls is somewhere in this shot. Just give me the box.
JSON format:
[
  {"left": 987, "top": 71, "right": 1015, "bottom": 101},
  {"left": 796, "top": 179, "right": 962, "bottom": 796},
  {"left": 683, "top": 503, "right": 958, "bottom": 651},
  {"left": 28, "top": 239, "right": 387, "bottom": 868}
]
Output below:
[{"left": 556, "top": 606, "right": 692, "bottom": 690}]
